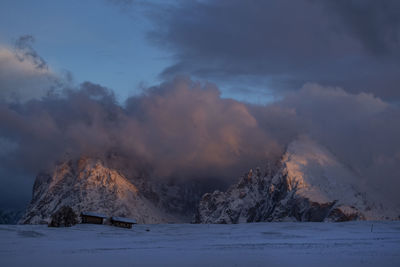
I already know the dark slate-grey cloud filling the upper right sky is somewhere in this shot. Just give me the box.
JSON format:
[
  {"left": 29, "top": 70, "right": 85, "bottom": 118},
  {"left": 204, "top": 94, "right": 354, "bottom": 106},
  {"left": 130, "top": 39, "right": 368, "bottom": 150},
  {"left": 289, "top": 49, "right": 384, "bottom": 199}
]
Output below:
[{"left": 150, "top": 0, "right": 400, "bottom": 100}]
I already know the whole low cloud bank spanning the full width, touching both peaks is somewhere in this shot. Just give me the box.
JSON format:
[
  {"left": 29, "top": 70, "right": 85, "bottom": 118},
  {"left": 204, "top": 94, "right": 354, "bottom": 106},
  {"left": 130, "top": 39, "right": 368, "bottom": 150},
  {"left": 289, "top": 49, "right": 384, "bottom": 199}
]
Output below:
[{"left": 0, "top": 77, "right": 400, "bottom": 207}]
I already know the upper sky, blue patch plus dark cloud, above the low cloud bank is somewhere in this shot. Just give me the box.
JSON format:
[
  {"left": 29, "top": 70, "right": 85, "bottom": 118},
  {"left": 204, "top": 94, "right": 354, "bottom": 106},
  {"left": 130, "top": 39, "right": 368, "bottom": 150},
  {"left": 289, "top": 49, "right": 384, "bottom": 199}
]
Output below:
[{"left": 0, "top": 0, "right": 400, "bottom": 104}]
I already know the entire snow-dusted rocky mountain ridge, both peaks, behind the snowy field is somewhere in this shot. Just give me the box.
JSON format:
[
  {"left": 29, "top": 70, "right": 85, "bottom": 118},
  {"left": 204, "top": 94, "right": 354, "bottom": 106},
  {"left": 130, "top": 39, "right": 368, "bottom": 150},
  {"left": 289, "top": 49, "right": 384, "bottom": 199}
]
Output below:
[{"left": 20, "top": 138, "right": 400, "bottom": 224}]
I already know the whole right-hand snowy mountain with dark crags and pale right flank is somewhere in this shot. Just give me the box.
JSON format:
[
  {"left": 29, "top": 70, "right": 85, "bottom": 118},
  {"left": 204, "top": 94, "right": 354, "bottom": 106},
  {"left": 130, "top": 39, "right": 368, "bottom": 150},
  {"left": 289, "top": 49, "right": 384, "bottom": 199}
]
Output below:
[{"left": 195, "top": 138, "right": 400, "bottom": 223}]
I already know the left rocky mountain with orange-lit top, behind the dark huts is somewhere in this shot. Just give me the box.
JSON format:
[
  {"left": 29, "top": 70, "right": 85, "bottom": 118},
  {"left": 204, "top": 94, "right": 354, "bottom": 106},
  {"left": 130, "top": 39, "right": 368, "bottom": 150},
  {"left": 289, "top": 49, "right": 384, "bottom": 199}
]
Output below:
[{"left": 20, "top": 159, "right": 177, "bottom": 224}]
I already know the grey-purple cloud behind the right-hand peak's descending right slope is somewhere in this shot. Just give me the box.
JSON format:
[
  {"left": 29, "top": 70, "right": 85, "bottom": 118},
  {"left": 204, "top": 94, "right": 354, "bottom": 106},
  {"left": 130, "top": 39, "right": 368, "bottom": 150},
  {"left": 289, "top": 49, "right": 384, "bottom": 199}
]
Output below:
[{"left": 278, "top": 84, "right": 400, "bottom": 201}]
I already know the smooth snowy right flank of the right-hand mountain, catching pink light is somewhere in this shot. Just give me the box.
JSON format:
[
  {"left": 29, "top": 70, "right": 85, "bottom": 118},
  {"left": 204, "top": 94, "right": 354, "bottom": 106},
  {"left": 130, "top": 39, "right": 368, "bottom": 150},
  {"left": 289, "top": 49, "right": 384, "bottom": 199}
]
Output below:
[{"left": 283, "top": 137, "right": 400, "bottom": 220}]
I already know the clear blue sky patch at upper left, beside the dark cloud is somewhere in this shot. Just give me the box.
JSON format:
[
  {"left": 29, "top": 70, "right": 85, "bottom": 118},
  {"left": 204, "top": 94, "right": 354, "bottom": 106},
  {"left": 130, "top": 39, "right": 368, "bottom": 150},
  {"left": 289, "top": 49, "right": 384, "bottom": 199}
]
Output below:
[{"left": 0, "top": 0, "right": 170, "bottom": 100}]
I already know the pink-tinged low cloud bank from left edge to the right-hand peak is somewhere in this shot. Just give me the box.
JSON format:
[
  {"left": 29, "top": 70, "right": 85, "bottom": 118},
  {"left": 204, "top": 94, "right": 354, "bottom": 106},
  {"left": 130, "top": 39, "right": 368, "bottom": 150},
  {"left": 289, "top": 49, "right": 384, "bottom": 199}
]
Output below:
[{"left": 0, "top": 78, "right": 284, "bottom": 210}]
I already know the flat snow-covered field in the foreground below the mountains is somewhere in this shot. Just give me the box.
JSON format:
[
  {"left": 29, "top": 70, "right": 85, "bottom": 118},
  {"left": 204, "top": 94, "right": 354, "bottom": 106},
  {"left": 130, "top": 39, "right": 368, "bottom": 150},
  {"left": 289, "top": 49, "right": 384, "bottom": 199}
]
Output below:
[{"left": 0, "top": 221, "right": 400, "bottom": 267}]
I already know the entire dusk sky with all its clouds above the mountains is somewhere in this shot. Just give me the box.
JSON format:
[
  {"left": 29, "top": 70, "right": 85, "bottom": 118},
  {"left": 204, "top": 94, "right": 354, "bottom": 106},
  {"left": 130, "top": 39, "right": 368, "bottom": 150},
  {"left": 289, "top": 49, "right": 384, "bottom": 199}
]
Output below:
[{"left": 0, "top": 0, "right": 400, "bottom": 211}]
